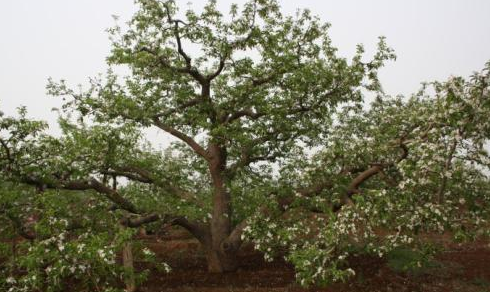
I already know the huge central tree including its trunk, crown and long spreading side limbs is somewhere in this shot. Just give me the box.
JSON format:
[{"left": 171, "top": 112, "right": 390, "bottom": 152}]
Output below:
[{"left": 0, "top": 0, "right": 490, "bottom": 285}]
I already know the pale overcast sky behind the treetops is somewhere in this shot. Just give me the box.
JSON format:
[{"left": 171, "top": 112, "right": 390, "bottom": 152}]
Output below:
[{"left": 0, "top": 0, "right": 490, "bottom": 140}]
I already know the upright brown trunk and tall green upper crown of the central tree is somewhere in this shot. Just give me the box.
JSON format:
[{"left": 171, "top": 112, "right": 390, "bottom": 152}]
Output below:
[{"left": 42, "top": 0, "right": 392, "bottom": 272}]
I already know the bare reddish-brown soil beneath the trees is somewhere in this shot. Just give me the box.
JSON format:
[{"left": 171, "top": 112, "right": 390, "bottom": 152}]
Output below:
[{"left": 133, "top": 231, "right": 490, "bottom": 292}]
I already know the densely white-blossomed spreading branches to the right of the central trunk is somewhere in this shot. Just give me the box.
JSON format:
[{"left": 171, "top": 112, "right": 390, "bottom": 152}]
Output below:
[{"left": 245, "top": 63, "right": 490, "bottom": 285}]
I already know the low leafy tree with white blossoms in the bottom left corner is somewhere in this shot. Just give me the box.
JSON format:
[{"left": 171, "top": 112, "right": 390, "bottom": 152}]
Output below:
[{"left": 0, "top": 178, "right": 149, "bottom": 292}]
